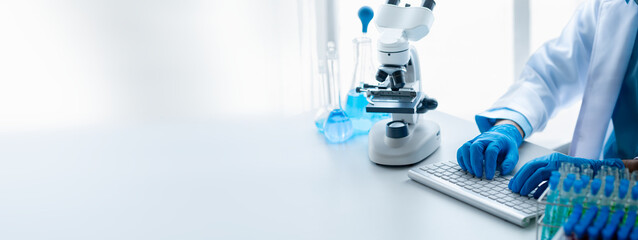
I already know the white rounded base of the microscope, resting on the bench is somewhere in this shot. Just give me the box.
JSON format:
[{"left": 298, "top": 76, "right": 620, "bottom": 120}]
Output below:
[{"left": 368, "top": 119, "right": 441, "bottom": 166}]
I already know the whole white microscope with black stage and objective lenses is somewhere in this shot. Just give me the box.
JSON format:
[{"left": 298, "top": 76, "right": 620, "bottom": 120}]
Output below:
[{"left": 357, "top": 0, "right": 441, "bottom": 166}]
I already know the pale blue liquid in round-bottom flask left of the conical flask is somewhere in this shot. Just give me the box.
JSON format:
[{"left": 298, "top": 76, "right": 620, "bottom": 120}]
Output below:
[{"left": 323, "top": 109, "right": 353, "bottom": 143}]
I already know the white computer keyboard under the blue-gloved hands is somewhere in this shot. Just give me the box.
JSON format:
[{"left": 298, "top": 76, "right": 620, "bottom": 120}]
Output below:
[{"left": 408, "top": 161, "right": 544, "bottom": 227}]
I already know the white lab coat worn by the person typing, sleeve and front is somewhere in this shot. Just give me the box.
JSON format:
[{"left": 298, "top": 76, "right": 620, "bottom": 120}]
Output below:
[{"left": 484, "top": 0, "right": 638, "bottom": 159}]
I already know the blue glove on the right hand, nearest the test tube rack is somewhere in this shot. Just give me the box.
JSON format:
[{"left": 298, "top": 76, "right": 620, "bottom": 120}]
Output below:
[{"left": 509, "top": 153, "right": 625, "bottom": 195}]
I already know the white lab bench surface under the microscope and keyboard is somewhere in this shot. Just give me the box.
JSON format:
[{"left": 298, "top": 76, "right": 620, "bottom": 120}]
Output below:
[{"left": 0, "top": 111, "right": 552, "bottom": 239}]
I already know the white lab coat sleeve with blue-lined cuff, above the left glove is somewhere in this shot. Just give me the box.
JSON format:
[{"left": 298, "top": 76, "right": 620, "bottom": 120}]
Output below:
[{"left": 476, "top": 0, "right": 604, "bottom": 137}]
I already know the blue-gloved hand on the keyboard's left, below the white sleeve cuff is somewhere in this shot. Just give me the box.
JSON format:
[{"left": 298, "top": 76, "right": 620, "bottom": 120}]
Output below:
[{"left": 456, "top": 124, "right": 523, "bottom": 180}]
